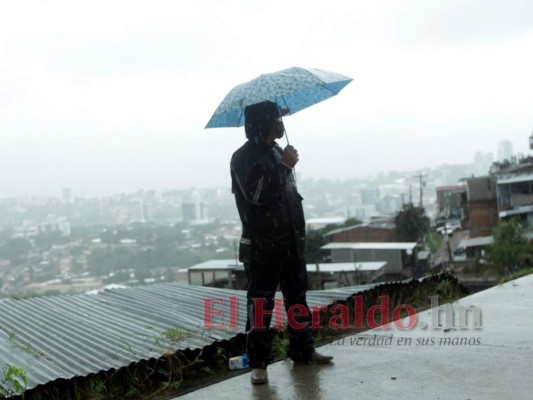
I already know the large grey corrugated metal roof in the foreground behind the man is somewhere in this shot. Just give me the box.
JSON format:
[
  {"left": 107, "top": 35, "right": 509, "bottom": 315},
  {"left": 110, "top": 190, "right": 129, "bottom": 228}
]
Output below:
[{"left": 0, "top": 283, "right": 377, "bottom": 389}]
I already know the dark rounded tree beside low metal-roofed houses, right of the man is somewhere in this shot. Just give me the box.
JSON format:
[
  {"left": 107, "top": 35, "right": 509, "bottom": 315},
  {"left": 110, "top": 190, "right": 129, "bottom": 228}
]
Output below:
[{"left": 394, "top": 203, "right": 429, "bottom": 242}]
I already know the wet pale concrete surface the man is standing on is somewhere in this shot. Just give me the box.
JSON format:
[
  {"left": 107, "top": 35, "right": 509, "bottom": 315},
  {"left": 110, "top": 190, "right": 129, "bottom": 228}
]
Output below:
[{"left": 179, "top": 275, "right": 533, "bottom": 400}]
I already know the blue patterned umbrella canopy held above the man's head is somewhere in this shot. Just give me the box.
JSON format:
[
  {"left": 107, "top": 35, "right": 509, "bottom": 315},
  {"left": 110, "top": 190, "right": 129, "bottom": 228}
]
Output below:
[{"left": 206, "top": 67, "right": 352, "bottom": 128}]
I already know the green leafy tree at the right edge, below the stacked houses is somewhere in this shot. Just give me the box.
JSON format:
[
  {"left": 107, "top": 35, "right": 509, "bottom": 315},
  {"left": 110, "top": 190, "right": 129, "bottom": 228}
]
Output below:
[{"left": 485, "top": 219, "right": 532, "bottom": 278}]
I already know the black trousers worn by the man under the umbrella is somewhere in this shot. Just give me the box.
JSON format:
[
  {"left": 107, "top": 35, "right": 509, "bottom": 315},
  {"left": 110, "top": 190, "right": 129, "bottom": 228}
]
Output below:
[{"left": 244, "top": 239, "right": 314, "bottom": 368}]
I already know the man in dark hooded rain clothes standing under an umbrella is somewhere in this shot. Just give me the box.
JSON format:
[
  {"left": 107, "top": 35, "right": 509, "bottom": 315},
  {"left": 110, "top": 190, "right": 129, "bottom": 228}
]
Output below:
[{"left": 231, "top": 101, "right": 333, "bottom": 384}]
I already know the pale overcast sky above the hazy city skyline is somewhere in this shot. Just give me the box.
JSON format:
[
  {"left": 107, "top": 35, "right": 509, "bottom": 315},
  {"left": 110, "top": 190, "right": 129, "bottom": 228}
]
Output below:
[{"left": 0, "top": 0, "right": 533, "bottom": 197}]
